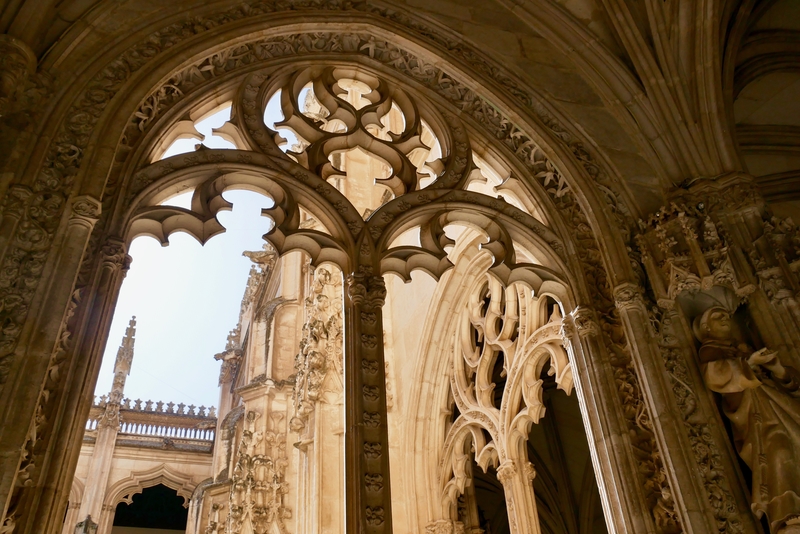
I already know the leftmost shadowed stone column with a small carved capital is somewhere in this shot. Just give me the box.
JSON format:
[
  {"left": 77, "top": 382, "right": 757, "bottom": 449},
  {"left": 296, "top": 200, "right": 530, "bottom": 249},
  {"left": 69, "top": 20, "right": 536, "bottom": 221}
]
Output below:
[{"left": 0, "top": 196, "right": 100, "bottom": 532}]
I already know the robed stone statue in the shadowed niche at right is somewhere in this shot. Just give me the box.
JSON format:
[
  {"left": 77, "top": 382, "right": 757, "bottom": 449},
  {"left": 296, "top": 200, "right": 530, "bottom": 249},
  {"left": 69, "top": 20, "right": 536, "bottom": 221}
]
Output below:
[{"left": 693, "top": 307, "right": 800, "bottom": 534}]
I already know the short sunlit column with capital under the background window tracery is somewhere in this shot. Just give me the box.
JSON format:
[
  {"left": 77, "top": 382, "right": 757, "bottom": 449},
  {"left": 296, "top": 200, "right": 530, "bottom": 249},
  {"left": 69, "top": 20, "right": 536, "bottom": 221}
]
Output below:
[{"left": 497, "top": 460, "right": 541, "bottom": 534}]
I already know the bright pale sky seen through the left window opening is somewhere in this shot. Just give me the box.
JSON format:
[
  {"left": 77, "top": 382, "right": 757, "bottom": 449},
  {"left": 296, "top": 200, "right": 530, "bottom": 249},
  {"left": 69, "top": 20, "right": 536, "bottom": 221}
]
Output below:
[{"left": 95, "top": 99, "right": 294, "bottom": 406}]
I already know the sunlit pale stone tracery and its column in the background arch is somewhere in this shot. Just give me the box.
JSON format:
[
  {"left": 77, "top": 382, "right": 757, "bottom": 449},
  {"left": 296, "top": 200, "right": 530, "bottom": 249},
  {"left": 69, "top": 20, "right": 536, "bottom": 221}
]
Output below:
[{"left": 440, "top": 273, "right": 573, "bottom": 530}]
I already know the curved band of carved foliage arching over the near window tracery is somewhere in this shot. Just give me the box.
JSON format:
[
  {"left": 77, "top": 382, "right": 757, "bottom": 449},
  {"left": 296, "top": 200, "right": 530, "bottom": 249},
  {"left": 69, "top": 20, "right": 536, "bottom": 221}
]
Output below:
[{"left": 45, "top": 13, "right": 644, "bottom": 302}]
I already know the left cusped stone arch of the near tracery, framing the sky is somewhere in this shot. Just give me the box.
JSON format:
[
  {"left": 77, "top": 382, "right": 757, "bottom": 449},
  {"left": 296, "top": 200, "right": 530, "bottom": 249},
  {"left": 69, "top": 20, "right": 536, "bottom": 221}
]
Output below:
[{"left": 124, "top": 150, "right": 363, "bottom": 266}]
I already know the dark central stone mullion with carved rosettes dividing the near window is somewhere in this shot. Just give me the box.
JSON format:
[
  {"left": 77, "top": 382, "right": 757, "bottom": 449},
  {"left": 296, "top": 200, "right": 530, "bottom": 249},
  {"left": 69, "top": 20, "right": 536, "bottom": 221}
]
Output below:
[{"left": 344, "top": 267, "right": 392, "bottom": 533}]
